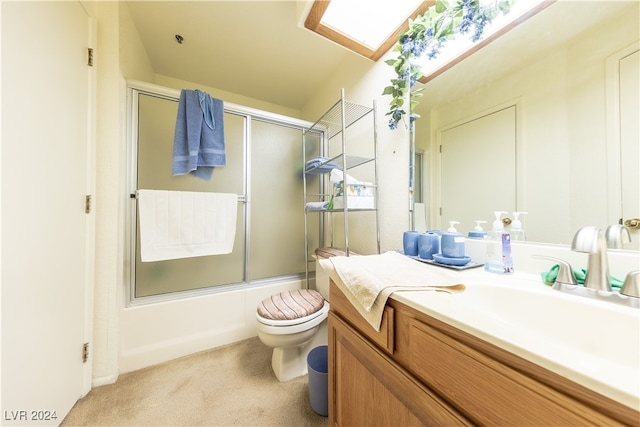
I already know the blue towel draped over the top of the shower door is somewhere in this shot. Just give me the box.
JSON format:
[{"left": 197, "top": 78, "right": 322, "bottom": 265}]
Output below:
[{"left": 172, "top": 89, "right": 227, "bottom": 180}]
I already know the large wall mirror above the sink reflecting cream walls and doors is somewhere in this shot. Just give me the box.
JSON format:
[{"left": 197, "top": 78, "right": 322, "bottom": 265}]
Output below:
[{"left": 416, "top": 0, "right": 640, "bottom": 250}]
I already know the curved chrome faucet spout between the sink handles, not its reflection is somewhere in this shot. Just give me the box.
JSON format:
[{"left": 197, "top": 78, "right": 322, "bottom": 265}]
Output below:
[{"left": 571, "top": 226, "right": 611, "bottom": 292}]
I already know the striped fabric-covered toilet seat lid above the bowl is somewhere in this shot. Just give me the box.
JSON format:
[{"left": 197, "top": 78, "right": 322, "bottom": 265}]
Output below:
[{"left": 258, "top": 289, "right": 324, "bottom": 320}]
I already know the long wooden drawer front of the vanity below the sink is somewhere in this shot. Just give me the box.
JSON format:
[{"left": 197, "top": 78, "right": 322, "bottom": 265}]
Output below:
[{"left": 409, "top": 319, "right": 619, "bottom": 426}]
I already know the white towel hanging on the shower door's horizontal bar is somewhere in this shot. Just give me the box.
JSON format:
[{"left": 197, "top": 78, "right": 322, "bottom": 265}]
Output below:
[{"left": 138, "top": 190, "right": 238, "bottom": 262}]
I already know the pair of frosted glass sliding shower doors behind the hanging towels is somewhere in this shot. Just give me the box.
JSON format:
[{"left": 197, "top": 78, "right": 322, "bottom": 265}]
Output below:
[{"left": 130, "top": 90, "right": 312, "bottom": 302}]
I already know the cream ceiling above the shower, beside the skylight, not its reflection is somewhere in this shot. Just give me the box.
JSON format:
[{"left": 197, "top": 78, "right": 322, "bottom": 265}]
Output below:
[{"left": 127, "top": 0, "right": 356, "bottom": 109}]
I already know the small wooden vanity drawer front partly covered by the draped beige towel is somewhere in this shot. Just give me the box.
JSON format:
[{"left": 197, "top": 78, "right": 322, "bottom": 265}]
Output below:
[{"left": 329, "top": 280, "right": 394, "bottom": 354}]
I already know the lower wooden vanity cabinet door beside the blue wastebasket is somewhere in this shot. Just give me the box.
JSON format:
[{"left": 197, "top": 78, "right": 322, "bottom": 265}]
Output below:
[{"left": 329, "top": 313, "right": 468, "bottom": 427}]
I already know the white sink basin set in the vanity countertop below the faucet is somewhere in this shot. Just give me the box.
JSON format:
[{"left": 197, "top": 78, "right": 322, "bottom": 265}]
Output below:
[{"left": 453, "top": 285, "right": 640, "bottom": 372}]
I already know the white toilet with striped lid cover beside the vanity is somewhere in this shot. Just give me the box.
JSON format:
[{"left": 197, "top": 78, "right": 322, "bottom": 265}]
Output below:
[{"left": 256, "top": 256, "right": 329, "bottom": 382}]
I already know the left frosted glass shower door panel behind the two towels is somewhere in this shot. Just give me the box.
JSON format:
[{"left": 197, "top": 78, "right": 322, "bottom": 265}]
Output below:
[{"left": 135, "top": 93, "right": 246, "bottom": 298}]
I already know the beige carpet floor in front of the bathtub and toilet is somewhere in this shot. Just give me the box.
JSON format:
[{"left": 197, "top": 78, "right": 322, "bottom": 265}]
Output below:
[{"left": 62, "top": 338, "right": 327, "bottom": 427}]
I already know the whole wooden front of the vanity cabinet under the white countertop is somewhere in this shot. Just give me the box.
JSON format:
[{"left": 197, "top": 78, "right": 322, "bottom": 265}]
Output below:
[{"left": 329, "top": 281, "right": 640, "bottom": 426}]
